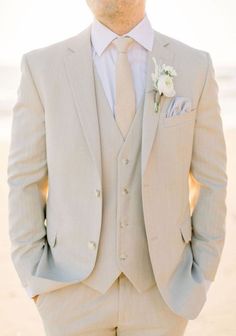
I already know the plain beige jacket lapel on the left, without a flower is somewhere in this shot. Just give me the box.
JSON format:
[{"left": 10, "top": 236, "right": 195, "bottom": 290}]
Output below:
[{"left": 65, "top": 25, "right": 101, "bottom": 180}]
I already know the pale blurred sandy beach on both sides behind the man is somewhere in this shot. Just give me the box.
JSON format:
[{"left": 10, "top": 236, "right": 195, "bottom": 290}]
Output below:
[{"left": 0, "top": 130, "right": 236, "bottom": 336}]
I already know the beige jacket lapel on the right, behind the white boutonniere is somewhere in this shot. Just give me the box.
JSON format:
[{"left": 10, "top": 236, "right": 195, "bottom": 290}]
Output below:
[{"left": 141, "top": 31, "right": 174, "bottom": 176}]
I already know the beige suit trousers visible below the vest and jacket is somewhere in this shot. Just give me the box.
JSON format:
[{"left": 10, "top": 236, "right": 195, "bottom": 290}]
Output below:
[{"left": 35, "top": 273, "right": 188, "bottom": 336}]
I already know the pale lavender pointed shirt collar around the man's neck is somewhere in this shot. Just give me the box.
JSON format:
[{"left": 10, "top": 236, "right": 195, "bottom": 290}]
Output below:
[{"left": 91, "top": 14, "right": 154, "bottom": 56}]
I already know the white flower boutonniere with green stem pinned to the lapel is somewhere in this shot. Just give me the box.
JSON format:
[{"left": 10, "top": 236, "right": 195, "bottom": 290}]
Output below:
[{"left": 152, "top": 57, "right": 177, "bottom": 112}]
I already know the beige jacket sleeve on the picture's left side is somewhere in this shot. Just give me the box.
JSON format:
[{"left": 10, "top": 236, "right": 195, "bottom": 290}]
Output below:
[{"left": 8, "top": 54, "right": 47, "bottom": 287}]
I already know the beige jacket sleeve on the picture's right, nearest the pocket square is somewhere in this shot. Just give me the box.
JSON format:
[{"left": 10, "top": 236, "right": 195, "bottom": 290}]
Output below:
[{"left": 190, "top": 53, "right": 227, "bottom": 281}]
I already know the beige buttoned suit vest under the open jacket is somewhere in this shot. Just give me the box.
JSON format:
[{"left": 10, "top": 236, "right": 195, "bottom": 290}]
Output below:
[{"left": 82, "top": 66, "right": 155, "bottom": 293}]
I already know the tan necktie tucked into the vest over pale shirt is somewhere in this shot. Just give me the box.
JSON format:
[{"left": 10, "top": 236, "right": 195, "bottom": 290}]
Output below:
[{"left": 112, "top": 36, "right": 135, "bottom": 138}]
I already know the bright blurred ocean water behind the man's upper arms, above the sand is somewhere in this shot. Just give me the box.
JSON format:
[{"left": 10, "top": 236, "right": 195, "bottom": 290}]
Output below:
[{"left": 0, "top": 64, "right": 236, "bottom": 140}]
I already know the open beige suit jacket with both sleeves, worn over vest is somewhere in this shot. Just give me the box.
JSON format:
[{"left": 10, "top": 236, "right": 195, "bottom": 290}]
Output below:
[{"left": 8, "top": 26, "right": 227, "bottom": 319}]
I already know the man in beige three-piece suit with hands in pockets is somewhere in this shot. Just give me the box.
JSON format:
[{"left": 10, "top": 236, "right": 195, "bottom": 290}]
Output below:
[{"left": 8, "top": 0, "right": 227, "bottom": 336}]
